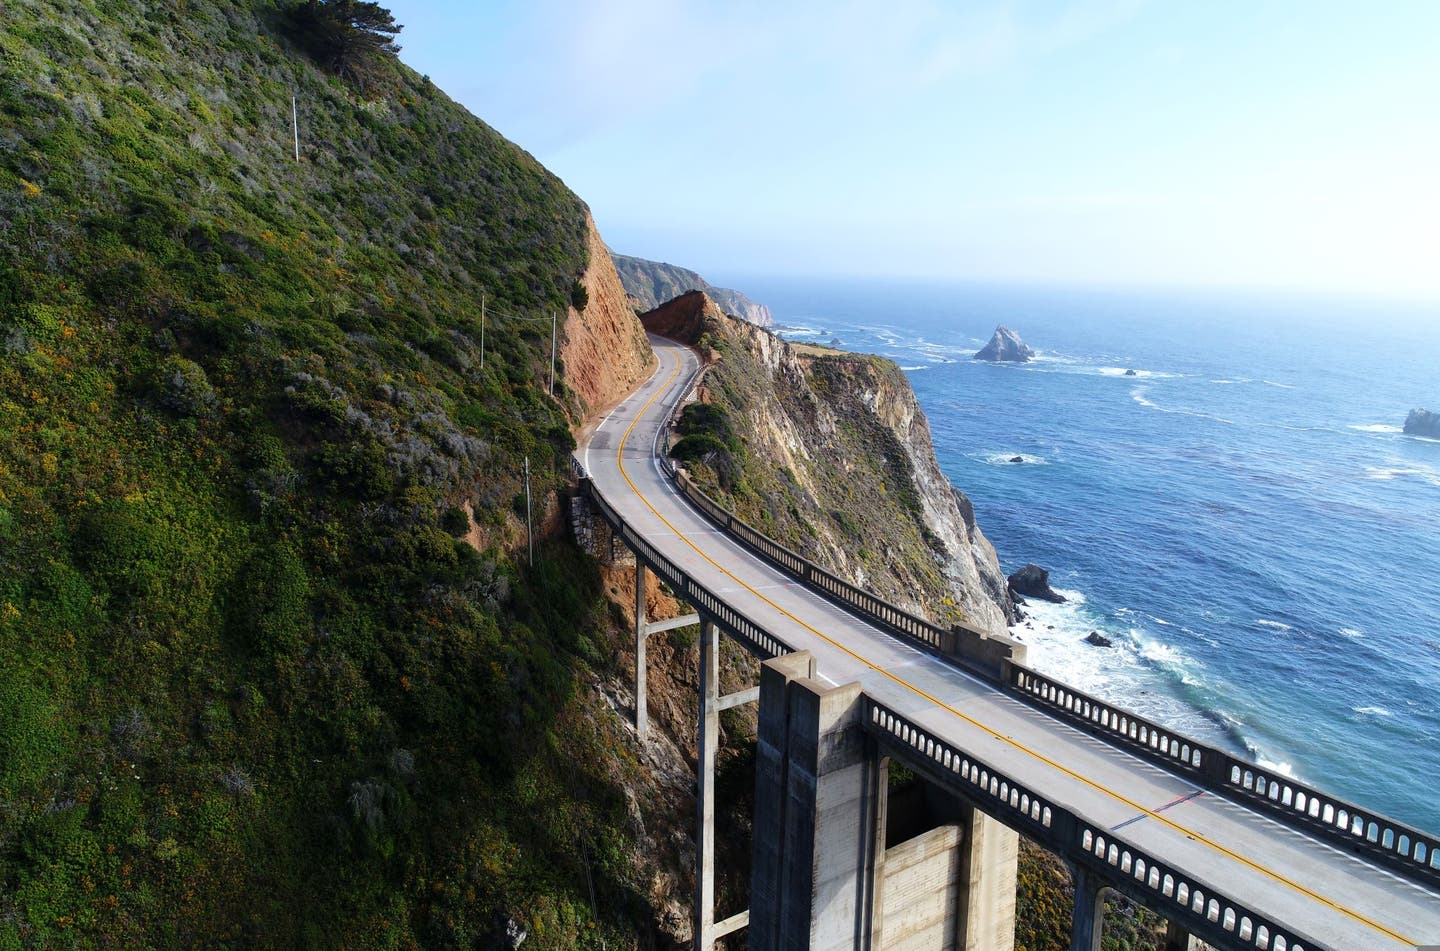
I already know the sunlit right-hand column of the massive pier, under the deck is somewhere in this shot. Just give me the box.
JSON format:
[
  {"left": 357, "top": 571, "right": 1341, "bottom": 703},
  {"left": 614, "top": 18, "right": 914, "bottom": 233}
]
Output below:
[{"left": 955, "top": 810, "right": 1025, "bottom": 951}]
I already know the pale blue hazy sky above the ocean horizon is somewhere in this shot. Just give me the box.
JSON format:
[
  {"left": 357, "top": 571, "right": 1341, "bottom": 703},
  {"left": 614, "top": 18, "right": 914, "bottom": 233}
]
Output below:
[{"left": 390, "top": 0, "right": 1440, "bottom": 300}]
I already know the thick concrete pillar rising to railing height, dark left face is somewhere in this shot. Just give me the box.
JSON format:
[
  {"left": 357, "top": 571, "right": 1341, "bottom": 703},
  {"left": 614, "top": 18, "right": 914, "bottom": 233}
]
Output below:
[{"left": 750, "top": 653, "right": 886, "bottom": 951}]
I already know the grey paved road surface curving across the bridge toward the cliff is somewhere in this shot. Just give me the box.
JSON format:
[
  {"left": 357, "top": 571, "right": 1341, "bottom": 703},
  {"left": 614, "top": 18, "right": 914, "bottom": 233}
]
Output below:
[{"left": 579, "top": 329, "right": 1440, "bottom": 951}]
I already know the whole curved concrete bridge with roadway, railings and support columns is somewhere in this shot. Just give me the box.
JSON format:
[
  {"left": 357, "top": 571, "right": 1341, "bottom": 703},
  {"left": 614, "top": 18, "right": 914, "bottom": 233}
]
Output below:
[{"left": 576, "top": 337, "right": 1440, "bottom": 951}]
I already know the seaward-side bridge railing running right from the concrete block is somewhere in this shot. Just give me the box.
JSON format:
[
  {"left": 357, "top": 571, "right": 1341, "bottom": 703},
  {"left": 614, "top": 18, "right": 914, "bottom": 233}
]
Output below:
[{"left": 1005, "top": 664, "right": 1440, "bottom": 885}]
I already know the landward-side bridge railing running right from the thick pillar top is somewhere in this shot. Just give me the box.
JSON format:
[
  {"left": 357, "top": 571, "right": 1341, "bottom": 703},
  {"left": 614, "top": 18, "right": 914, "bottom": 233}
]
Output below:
[{"left": 860, "top": 695, "right": 1325, "bottom": 951}]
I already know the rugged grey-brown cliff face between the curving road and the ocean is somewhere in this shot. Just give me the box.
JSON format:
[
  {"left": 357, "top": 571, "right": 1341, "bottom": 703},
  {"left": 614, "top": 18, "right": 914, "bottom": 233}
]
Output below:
[{"left": 642, "top": 294, "right": 1015, "bottom": 631}]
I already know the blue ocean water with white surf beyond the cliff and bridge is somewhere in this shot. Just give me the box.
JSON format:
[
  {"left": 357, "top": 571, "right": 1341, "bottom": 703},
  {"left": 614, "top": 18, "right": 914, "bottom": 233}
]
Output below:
[{"left": 736, "top": 277, "right": 1440, "bottom": 830}]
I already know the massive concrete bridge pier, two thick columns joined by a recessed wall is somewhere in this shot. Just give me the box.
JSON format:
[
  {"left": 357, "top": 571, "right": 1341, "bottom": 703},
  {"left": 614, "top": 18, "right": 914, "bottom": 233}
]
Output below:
[{"left": 750, "top": 653, "right": 1025, "bottom": 951}]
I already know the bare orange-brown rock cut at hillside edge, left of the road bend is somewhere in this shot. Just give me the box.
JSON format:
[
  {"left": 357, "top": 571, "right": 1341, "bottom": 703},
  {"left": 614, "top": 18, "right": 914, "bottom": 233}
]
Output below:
[{"left": 560, "top": 213, "right": 655, "bottom": 419}]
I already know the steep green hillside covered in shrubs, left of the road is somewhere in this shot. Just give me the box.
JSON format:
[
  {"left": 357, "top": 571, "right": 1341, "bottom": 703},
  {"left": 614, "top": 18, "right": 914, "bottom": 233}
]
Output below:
[{"left": 0, "top": 0, "right": 649, "bottom": 948}]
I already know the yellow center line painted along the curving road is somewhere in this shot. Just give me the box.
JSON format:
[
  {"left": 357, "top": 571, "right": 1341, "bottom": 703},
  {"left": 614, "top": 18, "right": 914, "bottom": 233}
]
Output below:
[{"left": 615, "top": 342, "right": 1418, "bottom": 945}]
